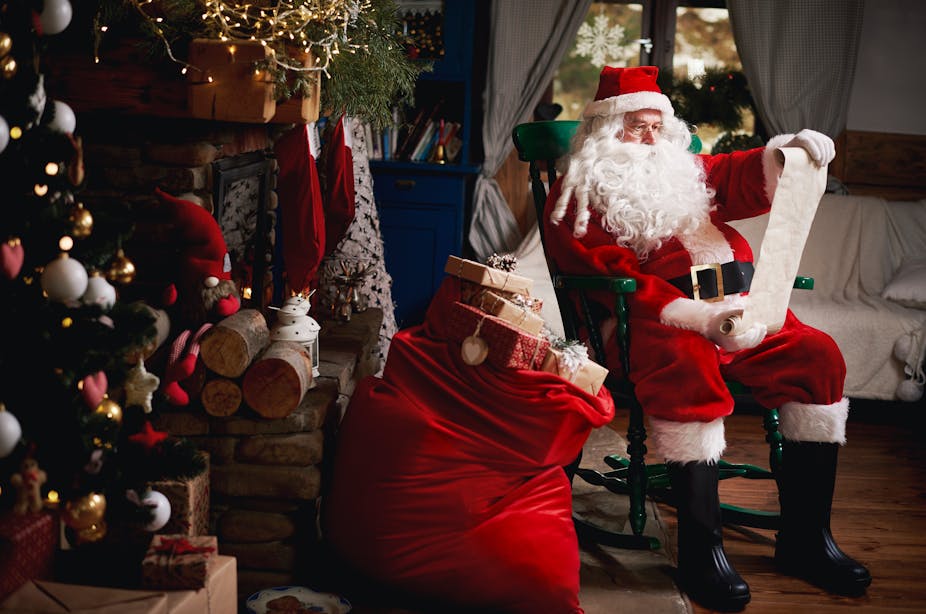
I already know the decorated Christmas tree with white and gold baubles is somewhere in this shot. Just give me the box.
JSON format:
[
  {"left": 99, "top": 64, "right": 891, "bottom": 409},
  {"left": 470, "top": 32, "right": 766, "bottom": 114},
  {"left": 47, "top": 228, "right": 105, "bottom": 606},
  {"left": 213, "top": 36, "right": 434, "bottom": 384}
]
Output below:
[{"left": 0, "top": 0, "right": 205, "bottom": 546}]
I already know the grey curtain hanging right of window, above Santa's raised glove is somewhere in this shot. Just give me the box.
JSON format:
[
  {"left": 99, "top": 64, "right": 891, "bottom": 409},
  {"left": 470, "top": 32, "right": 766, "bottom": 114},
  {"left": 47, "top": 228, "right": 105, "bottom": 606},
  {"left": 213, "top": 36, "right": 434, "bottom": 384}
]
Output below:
[{"left": 727, "top": 0, "right": 865, "bottom": 138}]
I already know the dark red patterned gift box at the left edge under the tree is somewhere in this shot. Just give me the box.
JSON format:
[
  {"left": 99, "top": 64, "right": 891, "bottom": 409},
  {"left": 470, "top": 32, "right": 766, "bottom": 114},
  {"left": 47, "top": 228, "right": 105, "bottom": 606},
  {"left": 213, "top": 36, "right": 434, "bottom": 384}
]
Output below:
[{"left": 0, "top": 512, "right": 58, "bottom": 599}]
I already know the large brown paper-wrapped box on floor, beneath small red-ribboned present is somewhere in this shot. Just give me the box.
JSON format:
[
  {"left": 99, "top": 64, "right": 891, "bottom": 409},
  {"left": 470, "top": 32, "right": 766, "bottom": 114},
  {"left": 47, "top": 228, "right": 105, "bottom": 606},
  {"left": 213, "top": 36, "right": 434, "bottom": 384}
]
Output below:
[{"left": 0, "top": 555, "right": 238, "bottom": 614}]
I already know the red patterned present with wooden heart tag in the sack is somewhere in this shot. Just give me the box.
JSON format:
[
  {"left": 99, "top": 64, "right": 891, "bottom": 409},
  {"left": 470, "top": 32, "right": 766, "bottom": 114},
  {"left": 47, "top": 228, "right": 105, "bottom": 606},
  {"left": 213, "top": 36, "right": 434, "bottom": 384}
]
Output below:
[{"left": 448, "top": 301, "right": 550, "bottom": 369}]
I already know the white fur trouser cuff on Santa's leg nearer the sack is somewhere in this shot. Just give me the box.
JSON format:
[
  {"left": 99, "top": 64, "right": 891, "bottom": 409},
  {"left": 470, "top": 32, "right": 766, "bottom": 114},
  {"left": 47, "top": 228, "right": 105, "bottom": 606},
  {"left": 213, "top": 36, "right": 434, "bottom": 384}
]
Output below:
[{"left": 649, "top": 418, "right": 727, "bottom": 463}]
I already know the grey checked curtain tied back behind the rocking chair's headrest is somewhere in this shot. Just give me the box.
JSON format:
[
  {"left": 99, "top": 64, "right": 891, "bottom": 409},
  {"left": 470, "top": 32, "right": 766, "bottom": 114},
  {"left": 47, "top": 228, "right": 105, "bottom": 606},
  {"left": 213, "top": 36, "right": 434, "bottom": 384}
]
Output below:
[{"left": 469, "top": 0, "right": 591, "bottom": 261}]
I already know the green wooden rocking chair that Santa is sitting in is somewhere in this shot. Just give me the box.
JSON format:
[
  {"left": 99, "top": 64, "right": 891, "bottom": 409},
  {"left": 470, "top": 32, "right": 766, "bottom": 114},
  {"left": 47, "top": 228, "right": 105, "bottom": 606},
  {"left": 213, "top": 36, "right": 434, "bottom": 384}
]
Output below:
[{"left": 512, "top": 120, "right": 813, "bottom": 549}]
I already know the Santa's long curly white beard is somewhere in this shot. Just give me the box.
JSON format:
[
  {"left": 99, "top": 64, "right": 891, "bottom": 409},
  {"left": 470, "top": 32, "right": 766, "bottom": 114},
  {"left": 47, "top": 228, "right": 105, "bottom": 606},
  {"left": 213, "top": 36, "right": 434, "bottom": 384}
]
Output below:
[{"left": 568, "top": 134, "right": 714, "bottom": 260}]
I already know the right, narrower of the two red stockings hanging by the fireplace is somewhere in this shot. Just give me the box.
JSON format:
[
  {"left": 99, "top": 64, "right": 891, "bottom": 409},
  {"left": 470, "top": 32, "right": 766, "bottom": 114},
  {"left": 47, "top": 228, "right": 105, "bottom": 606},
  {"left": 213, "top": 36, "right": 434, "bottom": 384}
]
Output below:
[{"left": 325, "top": 115, "right": 355, "bottom": 256}]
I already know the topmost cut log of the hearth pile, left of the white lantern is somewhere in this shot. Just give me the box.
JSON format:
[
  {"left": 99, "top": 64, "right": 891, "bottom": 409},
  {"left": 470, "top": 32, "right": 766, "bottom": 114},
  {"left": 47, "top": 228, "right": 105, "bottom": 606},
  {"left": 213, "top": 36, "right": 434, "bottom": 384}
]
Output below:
[{"left": 199, "top": 309, "right": 270, "bottom": 378}]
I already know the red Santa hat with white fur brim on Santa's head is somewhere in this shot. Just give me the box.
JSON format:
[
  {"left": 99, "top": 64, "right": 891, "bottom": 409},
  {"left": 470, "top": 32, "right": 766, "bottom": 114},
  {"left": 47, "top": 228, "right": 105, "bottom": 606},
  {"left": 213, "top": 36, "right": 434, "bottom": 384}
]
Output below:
[{"left": 583, "top": 66, "right": 675, "bottom": 119}]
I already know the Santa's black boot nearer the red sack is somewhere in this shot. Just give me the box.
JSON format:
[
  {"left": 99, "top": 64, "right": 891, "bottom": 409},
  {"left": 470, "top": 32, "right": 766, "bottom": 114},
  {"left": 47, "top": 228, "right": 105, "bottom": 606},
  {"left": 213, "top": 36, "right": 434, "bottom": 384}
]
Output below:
[{"left": 667, "top": 463, "right": 750, "bottom": 612}]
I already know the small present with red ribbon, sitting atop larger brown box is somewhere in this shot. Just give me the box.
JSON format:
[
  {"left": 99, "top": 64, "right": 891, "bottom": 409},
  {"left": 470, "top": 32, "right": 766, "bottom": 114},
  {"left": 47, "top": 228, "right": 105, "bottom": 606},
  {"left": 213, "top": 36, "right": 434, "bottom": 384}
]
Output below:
[{"left": 141, "top": 535, "right": 218, "bottom": 590}]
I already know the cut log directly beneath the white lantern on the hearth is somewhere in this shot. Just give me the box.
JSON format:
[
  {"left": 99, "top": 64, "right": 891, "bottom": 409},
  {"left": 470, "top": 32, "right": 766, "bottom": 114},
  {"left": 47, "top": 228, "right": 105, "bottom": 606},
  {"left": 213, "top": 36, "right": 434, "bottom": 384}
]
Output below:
[{"left": 241, "top": 341, "right": 315, "bottom": 418}]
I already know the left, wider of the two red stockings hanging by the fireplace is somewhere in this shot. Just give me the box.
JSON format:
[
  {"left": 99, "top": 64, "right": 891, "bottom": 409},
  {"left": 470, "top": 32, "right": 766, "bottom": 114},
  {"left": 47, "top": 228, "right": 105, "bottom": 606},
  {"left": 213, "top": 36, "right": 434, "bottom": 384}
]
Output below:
[{"left": 274, "top": 122, "right": 325, "bottom": 291}]
